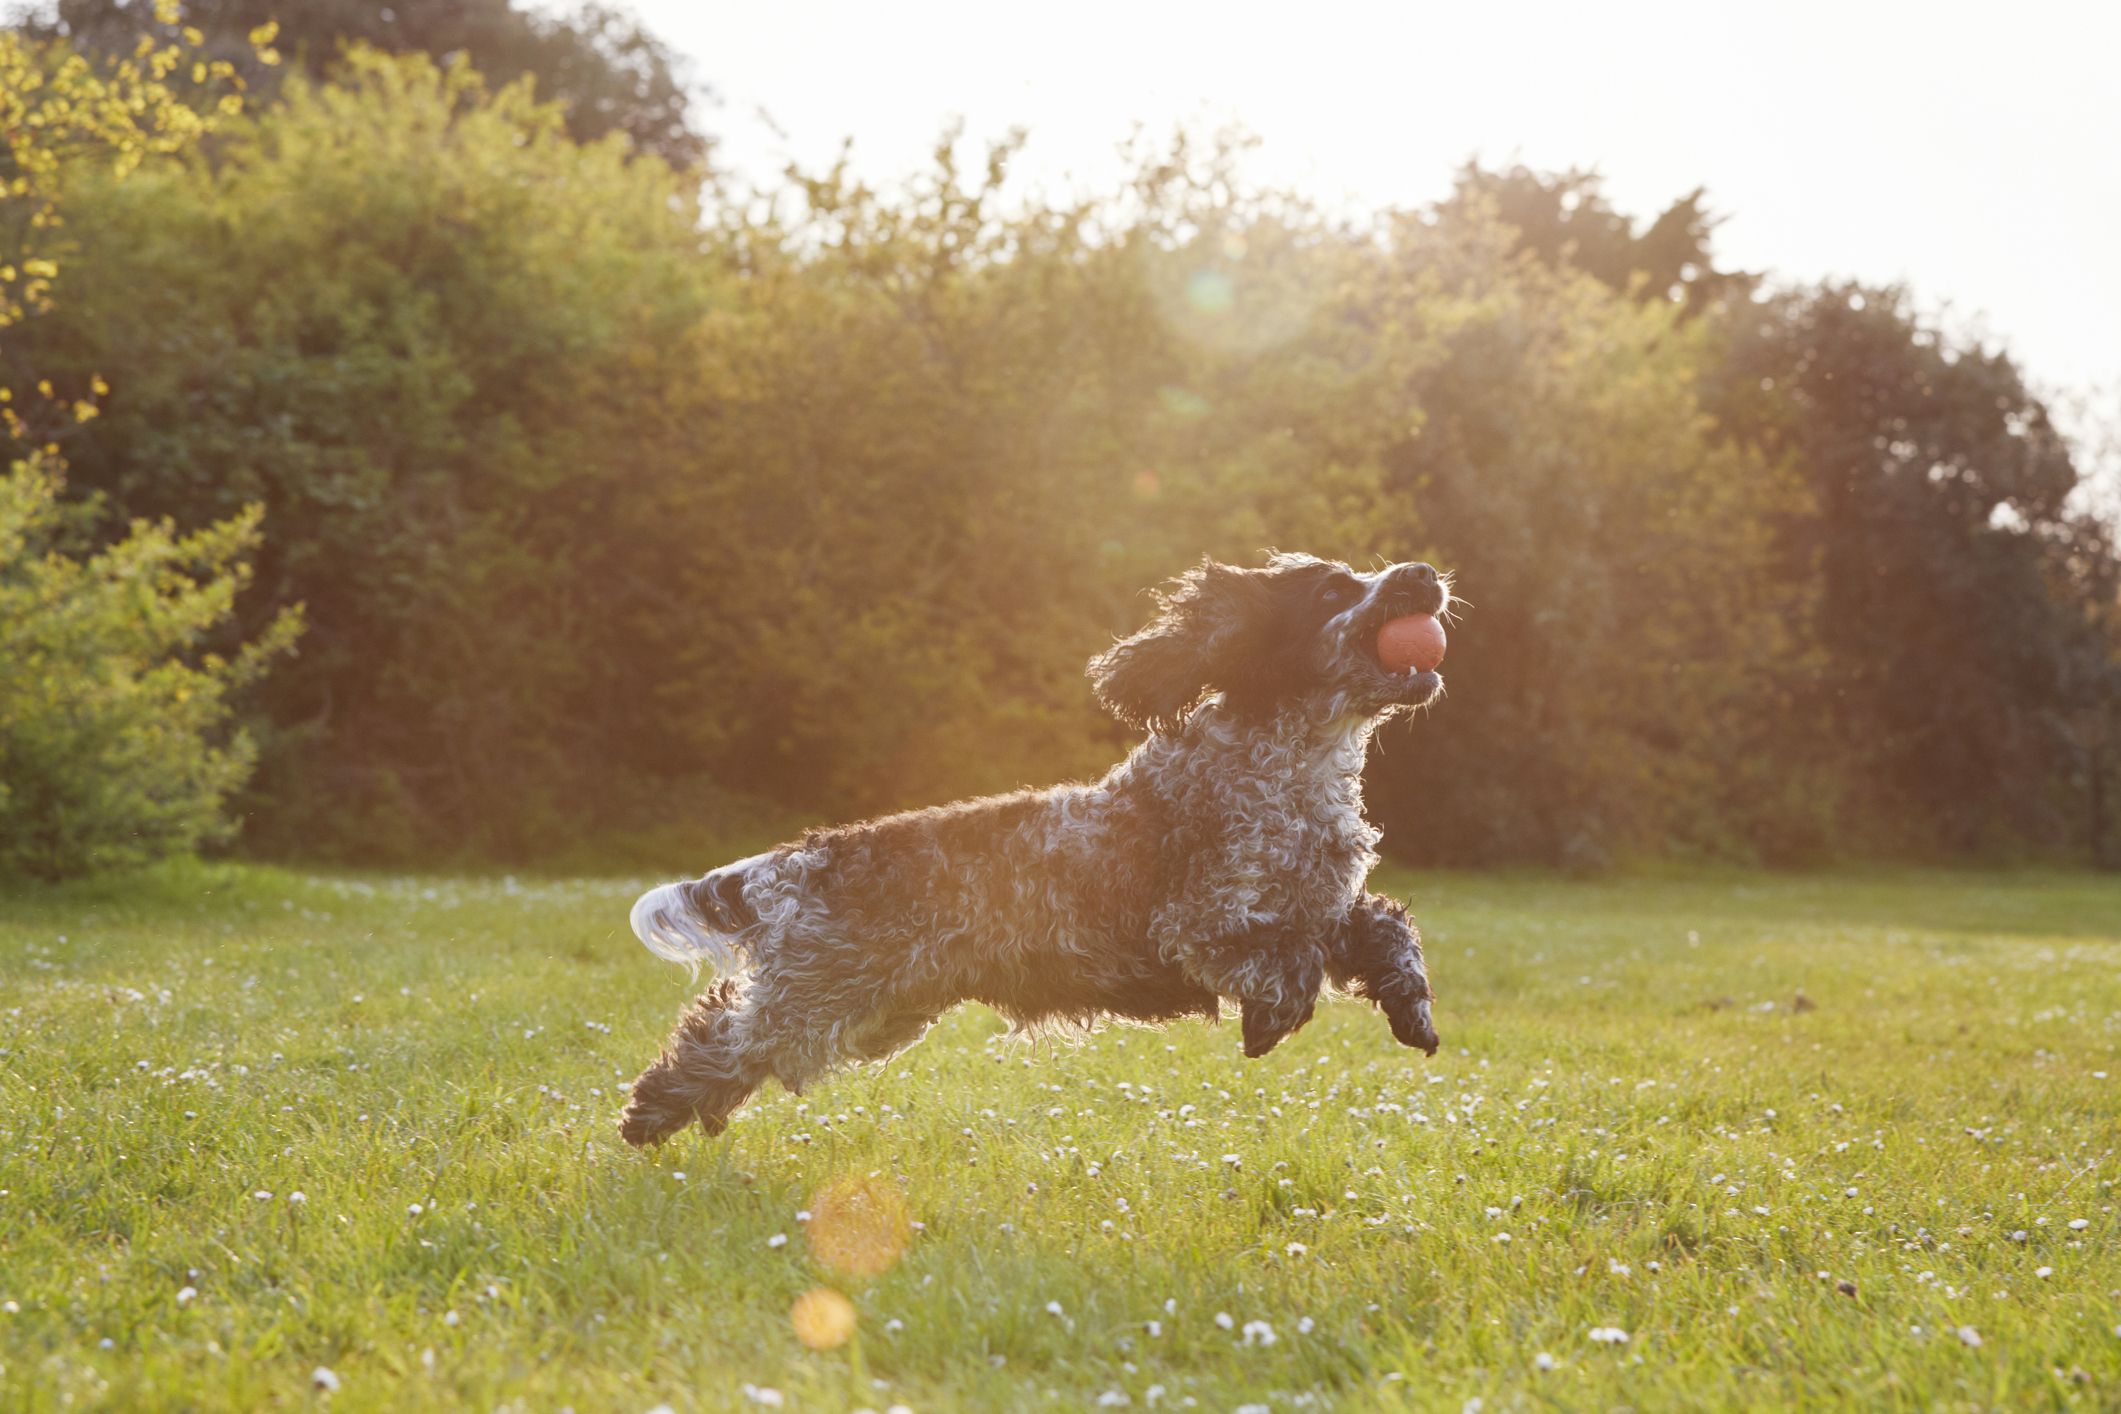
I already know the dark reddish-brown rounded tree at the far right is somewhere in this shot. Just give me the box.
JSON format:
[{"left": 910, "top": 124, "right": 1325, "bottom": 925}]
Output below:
[{"left": 1710, "top": 284, "right": 2121, "bottom": 852}]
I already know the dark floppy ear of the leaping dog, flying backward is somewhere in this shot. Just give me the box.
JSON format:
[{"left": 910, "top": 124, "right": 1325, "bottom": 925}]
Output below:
[{"left": 1090, "top": 560, "right": 1264, "bottom": 731}]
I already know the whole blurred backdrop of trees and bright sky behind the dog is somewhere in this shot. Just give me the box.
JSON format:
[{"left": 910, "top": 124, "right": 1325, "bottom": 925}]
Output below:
[{"left": 0, "top": 0, "right": 2121, "bottom": 878}]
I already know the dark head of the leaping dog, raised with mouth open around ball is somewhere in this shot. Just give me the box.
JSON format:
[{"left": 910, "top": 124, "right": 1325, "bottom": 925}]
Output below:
[{"left": 1090, "top": 555, "right": 1451, "bottom": 731}]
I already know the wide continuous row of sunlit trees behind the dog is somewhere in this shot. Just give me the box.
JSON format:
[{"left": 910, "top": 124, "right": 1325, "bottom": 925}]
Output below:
[{"left": 19, "top": 22, "right": 2117, "bottom": 867}]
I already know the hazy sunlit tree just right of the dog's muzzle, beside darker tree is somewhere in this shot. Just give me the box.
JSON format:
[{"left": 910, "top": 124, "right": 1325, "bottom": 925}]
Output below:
[{"left": 1372, "top": 218, "right": 1807, "bottom": 865}]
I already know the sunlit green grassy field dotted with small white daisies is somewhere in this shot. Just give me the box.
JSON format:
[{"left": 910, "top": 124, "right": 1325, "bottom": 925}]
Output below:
[{"left": 0, "top": 867, "right": 2121, "bottom": 1414}]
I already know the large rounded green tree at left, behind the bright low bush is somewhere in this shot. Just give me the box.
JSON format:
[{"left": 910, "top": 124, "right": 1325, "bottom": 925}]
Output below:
[{"left": 14, "top": 49, "right": 717, "bottom": 854}]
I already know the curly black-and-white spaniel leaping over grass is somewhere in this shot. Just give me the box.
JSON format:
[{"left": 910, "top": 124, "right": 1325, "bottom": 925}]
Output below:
[{"left": 619, "top": 553, "right": 1451, "bottom": 1145}]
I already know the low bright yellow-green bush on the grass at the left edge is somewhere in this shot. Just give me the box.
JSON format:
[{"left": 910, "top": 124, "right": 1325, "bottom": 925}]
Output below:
[{"left": 0, "top": 456, "right": 299, "bottom": 880}]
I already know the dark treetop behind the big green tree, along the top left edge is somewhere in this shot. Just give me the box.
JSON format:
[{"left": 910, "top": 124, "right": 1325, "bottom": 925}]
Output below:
[{"left": 32, "top": 0, "right": 708, "bottom": 170}]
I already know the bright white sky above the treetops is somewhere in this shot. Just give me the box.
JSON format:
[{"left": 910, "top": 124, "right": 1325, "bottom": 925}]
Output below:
[{"left": 632, "top": 0, "right": 2121, "bottom": 402}]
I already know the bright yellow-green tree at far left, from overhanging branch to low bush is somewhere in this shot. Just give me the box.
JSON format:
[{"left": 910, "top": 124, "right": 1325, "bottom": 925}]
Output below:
[{"left": 0, "top": 6, "right": 299, "bottom": 880}]
